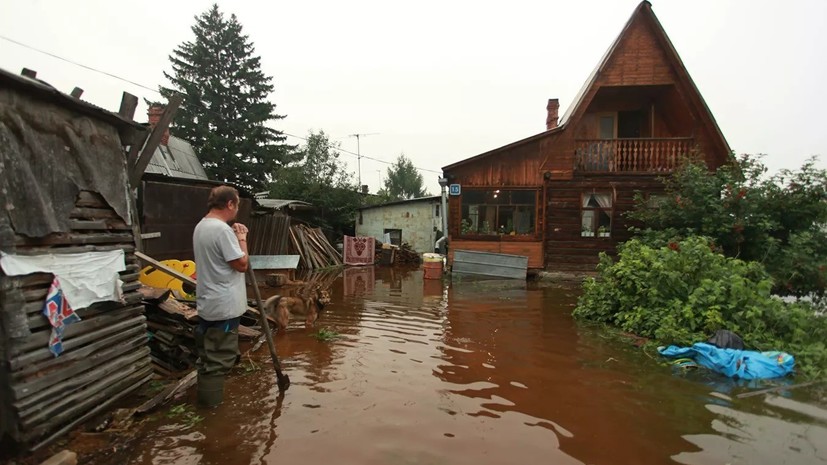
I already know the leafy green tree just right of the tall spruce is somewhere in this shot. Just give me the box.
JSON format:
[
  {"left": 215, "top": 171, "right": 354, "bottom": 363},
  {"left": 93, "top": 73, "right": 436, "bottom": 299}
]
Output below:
[{"left": 270, "top": 131, "right": 362, "bottom": 237}]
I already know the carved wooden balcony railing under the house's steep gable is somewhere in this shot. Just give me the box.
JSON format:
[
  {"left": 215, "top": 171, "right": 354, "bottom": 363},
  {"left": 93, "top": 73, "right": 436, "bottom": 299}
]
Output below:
[{"left": 574, "top": 137, "right": 695, "bottom": 173}]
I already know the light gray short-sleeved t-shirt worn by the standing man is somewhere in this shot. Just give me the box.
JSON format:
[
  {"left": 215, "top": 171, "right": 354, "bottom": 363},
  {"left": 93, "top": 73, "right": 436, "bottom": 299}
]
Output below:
[{"left": 192, "top": 218, "right": 247, "bottom": 321}]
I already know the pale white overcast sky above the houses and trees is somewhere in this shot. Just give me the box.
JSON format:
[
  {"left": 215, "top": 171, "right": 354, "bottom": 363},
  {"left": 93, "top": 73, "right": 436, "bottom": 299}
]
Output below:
[{"left": 0, "top": 0, "right": 827, "bottom": 193}]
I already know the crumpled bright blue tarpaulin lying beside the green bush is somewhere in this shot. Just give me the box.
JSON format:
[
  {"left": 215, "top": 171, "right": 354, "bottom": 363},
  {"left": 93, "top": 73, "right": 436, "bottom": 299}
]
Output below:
[{"left": 658, "top": 342, "right": 795, "bottom": 379}]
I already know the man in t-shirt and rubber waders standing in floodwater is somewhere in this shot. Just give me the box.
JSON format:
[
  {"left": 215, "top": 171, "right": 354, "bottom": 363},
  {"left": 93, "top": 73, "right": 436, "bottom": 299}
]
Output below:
[{"left": 192, "top": 186, "right": 249, "bottom": 407}]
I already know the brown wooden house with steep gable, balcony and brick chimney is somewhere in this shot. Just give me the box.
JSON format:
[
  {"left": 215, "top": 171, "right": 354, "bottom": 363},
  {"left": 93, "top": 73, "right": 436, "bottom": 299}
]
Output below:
[{"left": 443, "top": 1, "right": 732, "bottom": 271}]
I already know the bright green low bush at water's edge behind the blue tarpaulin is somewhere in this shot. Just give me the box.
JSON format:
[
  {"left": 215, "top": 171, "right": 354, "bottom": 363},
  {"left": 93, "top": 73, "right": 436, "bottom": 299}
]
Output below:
[{"left": 574, "top": 236, "right": 827, "bottom": 377}]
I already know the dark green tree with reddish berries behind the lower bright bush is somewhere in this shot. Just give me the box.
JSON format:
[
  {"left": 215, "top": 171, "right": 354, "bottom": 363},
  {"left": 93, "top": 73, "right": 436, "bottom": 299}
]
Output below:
[{"left": 629, "top": 156, "right": 827, "bottom": 296}]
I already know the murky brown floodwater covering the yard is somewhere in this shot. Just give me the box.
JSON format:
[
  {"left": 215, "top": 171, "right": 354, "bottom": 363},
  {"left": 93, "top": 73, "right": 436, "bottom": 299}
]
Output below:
[{"left": 117, "top": 267, "right": 827, "bottom": 465}]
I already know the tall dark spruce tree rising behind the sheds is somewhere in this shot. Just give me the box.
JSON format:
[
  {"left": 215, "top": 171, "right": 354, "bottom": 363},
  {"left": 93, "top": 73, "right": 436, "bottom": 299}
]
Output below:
[{"left": 161, "top": 5, "right": 291, "bottom": 191}]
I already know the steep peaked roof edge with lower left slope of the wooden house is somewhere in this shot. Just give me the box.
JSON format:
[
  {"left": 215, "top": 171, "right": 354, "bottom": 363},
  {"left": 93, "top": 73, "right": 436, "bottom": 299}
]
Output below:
[{"left": 442, "top": 0, "right": 731, "bottom": 171}]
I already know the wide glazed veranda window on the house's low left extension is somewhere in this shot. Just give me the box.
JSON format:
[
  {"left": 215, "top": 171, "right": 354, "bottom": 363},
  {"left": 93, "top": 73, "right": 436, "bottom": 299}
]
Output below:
[{"left": 460, "top": 189, "right": 537, "bottom": 236}]
